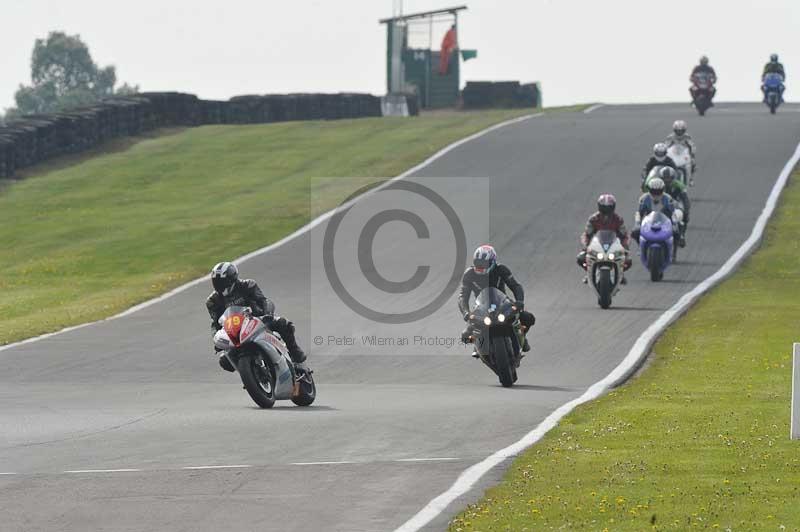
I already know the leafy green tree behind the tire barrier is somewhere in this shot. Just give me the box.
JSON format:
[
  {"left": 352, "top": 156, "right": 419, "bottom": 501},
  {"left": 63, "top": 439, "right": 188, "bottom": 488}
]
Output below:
[{"left": 6, "top": 31, "right": 139, "bottom": 118}]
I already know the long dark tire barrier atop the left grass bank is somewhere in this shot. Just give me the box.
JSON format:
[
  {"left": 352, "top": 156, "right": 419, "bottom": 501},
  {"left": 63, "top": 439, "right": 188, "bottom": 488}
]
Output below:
[{"left": 0, "top": 92, "right": 382, "bottom": 178}]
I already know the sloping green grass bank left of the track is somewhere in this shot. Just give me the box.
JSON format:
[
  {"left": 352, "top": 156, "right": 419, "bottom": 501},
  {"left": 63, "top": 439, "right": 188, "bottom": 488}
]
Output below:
[{"left": 0, "top": 110, "right": 568, "bottom": 344}]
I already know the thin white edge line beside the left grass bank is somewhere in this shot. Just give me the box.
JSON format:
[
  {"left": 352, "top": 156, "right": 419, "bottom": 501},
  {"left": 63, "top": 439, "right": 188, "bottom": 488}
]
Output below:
[{"left": 0, "top": 112, "right": 545, "bottom": 351}]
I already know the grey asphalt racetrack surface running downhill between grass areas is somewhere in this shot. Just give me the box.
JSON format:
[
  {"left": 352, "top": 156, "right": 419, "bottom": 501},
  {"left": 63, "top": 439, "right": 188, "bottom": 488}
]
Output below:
[{"left": 0, "top": 104, "right": 800, "bottom": 531}]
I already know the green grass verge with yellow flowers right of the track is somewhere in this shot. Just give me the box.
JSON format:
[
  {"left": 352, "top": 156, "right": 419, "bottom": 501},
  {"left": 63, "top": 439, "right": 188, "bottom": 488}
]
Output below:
[{"left": 450, "top": 172, "right": 800, "bottom": 532}]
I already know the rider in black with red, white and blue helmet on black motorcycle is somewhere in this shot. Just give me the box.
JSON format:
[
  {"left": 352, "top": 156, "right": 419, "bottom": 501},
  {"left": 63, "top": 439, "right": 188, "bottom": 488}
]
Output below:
[{"left": 458, "top": 244, "right": 536, "bottom": 356}]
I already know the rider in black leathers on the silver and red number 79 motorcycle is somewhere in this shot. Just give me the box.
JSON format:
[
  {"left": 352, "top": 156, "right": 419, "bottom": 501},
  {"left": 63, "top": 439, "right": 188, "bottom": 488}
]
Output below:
[{"left": 206, "top": 262, "right": 306, "bottom": 371}]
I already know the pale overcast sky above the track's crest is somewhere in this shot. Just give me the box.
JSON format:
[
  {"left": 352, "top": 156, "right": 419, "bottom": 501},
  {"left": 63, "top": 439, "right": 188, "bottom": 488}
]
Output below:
[{"left": 0, "top": 0, "right": 800, "bottom": 108}]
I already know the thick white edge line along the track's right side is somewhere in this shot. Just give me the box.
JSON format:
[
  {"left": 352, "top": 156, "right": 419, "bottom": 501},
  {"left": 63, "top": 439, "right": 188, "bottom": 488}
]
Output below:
[{"left": 395, "top": 139, "right": 800, "bottom": 532}]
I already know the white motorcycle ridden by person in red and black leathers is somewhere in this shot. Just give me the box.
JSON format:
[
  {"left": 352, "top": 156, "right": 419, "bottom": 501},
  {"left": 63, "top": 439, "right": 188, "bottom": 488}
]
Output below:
[{"left": 586, "top": 231, "right": 628, "bottom": 309}]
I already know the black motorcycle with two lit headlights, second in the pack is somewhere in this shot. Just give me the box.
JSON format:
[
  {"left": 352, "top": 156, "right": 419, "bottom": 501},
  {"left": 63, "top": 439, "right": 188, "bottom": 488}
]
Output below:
[{"left": 462, "top": 287, "right": 525, "bottom": 388}]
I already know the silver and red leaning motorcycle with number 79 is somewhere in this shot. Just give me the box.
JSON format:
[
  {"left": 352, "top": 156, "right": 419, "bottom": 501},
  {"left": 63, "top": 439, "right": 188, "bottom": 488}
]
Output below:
[{"left": 214, "top": 306, "right": 317, "bottom": 408}]
